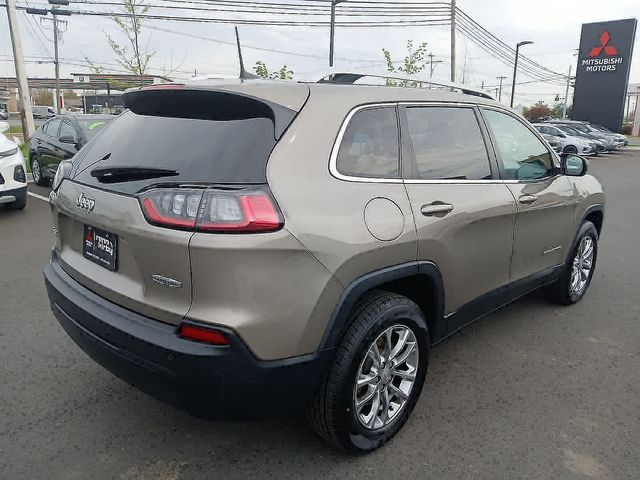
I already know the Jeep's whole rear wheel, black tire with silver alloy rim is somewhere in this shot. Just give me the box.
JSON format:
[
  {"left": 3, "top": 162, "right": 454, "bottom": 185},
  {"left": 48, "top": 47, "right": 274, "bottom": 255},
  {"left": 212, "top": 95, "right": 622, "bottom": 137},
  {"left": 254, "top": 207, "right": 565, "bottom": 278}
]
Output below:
[{"left": 307, "top": 291, "right": 429, "bottom": 453}]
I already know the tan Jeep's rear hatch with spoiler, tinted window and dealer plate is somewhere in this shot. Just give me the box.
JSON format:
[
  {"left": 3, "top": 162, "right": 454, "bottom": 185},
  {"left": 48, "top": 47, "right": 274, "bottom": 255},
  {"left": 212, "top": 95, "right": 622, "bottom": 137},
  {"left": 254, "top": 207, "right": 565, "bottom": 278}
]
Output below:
[{"left": 54, "top": 84, "right": 308, "bottom": 323}]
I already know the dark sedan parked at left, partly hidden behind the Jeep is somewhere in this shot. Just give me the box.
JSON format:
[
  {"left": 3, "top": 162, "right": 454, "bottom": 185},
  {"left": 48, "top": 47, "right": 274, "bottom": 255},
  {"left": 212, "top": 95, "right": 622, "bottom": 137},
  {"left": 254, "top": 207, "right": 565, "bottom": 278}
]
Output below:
[{"left": 29, "top": 114, "right": 114, "bottom": 185}]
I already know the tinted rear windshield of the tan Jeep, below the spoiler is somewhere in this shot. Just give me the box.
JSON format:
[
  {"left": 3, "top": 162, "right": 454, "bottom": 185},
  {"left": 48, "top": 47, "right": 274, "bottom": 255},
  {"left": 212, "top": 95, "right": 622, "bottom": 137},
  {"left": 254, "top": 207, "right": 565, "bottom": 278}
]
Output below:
[{"left": 74, "top": 90, "right": 293, "bottom": 194}]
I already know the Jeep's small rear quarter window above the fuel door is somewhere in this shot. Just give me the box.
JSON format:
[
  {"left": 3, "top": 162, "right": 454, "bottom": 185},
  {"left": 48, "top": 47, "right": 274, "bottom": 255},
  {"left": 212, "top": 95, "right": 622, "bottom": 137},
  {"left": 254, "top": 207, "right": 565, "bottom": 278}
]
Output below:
[{"left": 336, "top": 107, "right": 400, "bottom": 178}]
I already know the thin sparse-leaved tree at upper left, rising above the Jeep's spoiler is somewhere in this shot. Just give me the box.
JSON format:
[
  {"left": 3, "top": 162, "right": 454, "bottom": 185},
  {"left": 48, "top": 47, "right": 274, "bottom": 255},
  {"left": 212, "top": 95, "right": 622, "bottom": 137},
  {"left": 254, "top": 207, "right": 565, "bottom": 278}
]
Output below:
[{"left": 99, "top": 0, "right": 155, "bottom": 84}]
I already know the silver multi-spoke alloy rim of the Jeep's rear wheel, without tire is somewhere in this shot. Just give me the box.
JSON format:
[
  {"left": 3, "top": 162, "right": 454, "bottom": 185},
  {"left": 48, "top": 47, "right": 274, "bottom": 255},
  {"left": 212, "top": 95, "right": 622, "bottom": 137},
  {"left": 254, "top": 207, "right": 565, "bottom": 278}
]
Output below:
[{"left": 353, "top": 325, "right": 419, "bottom": 430}]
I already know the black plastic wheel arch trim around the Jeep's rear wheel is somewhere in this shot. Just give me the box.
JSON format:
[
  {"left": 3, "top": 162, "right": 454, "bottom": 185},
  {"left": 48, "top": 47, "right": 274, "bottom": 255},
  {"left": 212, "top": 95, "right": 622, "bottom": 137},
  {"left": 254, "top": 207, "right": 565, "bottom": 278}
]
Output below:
[{"left": 319, "top": 261, "right": 445, "bottom": 350}]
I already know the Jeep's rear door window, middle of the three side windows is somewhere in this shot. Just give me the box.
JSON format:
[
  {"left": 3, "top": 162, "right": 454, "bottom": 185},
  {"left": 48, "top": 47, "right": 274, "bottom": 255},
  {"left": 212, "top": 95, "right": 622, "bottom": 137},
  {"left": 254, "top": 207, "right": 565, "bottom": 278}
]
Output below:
[{"left": 404, "top": 107, "right": 491, "bottom": 180}]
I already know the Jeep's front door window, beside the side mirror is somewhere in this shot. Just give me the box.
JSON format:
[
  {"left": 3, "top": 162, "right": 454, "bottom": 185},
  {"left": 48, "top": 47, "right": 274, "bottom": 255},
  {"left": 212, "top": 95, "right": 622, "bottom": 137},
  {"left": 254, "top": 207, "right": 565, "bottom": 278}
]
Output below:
[{"left": 484, "top": 110, "right": 556, "bottom": 180}]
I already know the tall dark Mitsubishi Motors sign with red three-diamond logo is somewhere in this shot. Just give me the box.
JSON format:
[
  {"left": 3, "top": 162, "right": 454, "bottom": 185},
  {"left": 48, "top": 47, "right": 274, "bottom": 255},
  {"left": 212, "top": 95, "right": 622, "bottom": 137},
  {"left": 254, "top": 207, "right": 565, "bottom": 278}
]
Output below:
[{"left": 571, "top": 18, "right": 637, "bottom": 132}]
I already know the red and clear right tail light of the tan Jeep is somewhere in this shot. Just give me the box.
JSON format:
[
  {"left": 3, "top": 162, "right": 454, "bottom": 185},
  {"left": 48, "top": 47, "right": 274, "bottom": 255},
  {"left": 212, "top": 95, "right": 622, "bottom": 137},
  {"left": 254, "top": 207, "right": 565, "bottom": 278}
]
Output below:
[{"left": 139, "top": 187, "right": 283, "bottom": 233}]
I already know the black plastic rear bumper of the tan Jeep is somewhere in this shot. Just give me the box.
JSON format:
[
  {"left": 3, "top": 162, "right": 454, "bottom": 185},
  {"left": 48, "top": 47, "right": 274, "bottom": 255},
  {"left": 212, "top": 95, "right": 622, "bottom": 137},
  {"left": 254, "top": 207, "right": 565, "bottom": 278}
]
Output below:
[{"left": 44, "top": 255, "right": 332, "bottom": 417}]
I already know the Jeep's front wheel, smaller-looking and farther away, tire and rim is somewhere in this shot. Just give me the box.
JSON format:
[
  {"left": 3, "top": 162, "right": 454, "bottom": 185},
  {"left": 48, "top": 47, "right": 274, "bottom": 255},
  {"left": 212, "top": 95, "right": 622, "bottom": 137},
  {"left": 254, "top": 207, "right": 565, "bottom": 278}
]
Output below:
[{"left": 544, "top": 221, "right": 598, "bottom": 305}]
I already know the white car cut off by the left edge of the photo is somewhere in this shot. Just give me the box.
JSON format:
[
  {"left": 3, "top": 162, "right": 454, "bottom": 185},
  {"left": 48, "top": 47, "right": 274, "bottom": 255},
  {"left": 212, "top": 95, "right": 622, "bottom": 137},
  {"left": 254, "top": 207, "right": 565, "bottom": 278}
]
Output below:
[{"left": 0, "top": 122, "right": 27, "bottom": 210}]
